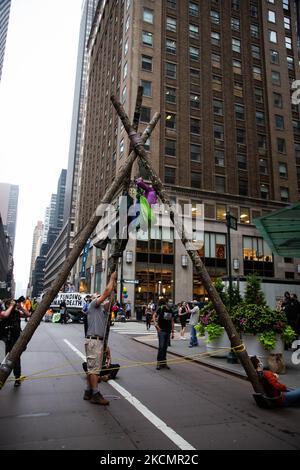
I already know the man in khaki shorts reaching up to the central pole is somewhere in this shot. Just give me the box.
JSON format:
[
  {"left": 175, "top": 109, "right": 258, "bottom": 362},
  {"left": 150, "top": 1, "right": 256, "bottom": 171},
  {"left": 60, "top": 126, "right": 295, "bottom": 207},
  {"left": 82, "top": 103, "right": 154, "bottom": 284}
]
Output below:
[{"left": 83, "top": 272, "right": 117, "bottom": 405}]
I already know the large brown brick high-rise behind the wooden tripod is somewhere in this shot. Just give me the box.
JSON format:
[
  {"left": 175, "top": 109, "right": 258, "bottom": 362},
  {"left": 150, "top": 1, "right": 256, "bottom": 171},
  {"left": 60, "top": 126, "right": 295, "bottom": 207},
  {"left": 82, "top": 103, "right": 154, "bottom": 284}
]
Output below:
[{"left": 78, "top": 0, "right": 300, "bottom": 304}]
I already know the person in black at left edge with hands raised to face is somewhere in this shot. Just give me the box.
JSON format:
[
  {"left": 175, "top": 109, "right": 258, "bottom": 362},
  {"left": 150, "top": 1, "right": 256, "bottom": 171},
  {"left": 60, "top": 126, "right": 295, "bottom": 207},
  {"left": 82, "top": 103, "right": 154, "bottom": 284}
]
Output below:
[{"left": 0, "top": 297, "right": 30, "bottom": 387}]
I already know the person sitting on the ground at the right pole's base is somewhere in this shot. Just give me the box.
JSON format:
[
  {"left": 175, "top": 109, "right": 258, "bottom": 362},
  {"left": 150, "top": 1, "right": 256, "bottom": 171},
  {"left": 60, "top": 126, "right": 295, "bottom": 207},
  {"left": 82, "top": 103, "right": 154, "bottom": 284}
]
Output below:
[{"left": 250, "top": 356, "right": 300, "bottom": 407}]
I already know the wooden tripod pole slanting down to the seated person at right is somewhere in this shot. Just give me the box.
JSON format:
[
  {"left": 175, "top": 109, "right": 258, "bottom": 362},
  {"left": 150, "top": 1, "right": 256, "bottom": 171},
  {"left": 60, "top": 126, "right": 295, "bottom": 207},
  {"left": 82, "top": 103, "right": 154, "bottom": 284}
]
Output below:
[{"left": 111, "top": 96, "right": 263, "bottom": 393}]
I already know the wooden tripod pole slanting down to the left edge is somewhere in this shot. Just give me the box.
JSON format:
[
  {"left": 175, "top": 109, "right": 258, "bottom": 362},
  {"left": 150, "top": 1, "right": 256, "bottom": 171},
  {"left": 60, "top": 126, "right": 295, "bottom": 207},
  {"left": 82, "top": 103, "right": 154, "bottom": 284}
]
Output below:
[{"left": 0, "top": 113, "right": 160, "bottom": 390}]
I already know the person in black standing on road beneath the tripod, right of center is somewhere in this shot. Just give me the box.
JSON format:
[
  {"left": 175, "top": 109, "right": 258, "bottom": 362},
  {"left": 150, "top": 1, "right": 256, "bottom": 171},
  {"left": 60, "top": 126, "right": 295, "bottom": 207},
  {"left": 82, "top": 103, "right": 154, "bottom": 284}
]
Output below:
[{"left": 153, "top": 299, "right": 174, "bottom": 370}]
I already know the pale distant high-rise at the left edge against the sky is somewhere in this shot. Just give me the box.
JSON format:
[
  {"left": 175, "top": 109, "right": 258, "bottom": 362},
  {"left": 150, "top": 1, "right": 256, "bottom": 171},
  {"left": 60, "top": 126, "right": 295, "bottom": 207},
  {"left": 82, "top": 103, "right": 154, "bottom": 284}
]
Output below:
[{"left": 0, "top": 183, "right": 19, "bottom": 250}]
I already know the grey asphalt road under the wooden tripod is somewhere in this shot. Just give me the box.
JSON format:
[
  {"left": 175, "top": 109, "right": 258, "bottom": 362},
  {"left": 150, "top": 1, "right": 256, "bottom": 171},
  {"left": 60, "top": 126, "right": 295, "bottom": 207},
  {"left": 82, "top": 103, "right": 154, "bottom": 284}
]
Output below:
[{"left": 0, "top": 323, "right": 300, "bottom": 450}]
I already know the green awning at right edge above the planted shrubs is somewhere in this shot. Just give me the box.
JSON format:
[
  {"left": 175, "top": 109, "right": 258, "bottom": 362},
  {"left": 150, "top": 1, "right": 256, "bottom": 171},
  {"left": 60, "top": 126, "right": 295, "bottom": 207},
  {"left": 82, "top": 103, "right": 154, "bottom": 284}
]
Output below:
[{"left": 253, "top": 202, "right": 300, "bottom": 258}]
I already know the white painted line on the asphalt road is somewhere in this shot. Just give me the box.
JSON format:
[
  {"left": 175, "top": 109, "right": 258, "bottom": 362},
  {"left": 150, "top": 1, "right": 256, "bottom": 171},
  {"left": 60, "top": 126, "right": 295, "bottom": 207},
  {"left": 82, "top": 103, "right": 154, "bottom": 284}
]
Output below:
[{"left": 64, "top": 339, "right": 196, "bottom": 450}]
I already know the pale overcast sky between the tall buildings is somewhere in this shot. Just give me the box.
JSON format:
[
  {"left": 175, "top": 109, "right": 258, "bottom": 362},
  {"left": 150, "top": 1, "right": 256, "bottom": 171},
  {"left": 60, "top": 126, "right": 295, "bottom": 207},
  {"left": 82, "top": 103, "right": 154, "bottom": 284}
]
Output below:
[{"left": 0, "top": 0, "right": 83, "bottom": 294}]
